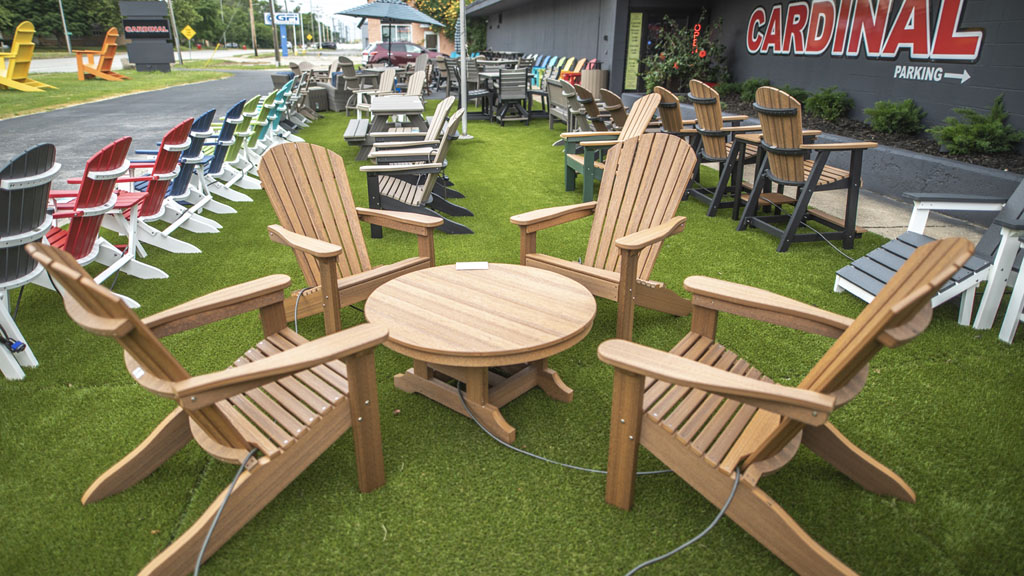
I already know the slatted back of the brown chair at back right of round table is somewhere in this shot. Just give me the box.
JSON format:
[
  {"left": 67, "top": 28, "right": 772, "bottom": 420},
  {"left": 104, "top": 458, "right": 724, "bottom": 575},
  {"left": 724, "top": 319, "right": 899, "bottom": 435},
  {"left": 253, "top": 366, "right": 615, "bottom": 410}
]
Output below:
[{"left": 583, "top": 133, "right": 696, "bottom": 280}]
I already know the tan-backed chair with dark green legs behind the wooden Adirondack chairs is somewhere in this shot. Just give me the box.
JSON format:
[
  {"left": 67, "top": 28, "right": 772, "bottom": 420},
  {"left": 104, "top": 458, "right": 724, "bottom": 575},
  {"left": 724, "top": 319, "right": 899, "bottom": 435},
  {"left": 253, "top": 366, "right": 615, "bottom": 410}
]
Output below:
[{"left": 561, "top": 90, "right": 662, "bottom": 202}]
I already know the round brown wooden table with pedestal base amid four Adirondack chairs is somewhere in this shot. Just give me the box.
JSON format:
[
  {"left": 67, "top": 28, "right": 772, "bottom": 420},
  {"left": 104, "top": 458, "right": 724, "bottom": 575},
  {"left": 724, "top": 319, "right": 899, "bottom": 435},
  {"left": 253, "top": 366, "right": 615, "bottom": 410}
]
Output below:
[{"left": 365, "top": 263, "right": 597, "bottom": 443}]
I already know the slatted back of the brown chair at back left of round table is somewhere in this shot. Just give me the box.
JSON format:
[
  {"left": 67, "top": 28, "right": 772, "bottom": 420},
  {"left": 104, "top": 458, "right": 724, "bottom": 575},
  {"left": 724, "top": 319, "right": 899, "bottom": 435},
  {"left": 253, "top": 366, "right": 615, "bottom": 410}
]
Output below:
[{"left": 259, "top": 142, "right": 372, "bottom": 286}]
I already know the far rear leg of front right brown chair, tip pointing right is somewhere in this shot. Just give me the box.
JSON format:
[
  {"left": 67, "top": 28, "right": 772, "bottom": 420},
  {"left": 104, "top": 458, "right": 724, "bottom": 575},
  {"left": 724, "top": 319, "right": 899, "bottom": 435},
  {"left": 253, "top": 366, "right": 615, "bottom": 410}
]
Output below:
[{"left": 803, "top": 422, "right": 916, "bottom": 502}]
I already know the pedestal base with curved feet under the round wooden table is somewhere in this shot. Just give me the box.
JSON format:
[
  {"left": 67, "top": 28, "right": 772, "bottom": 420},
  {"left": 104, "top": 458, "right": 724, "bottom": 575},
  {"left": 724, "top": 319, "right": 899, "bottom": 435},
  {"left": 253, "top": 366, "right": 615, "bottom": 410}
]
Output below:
[{"left": 394, "top": 360, "right": 572, "bottom": 444}]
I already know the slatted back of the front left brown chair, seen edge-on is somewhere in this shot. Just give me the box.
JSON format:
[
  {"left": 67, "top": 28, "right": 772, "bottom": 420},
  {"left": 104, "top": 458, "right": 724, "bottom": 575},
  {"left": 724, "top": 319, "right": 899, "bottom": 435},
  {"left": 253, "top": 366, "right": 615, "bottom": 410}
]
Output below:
[{"left": 27, "top": 244, "right": 258, "bottom": 461}]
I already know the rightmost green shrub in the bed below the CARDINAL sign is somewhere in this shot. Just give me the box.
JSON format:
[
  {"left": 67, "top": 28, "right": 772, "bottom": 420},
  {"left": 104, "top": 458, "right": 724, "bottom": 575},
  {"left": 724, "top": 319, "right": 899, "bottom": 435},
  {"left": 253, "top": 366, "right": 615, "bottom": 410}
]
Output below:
[{"left": 928, "top": 94, "right": 1024, "bottom": 154}]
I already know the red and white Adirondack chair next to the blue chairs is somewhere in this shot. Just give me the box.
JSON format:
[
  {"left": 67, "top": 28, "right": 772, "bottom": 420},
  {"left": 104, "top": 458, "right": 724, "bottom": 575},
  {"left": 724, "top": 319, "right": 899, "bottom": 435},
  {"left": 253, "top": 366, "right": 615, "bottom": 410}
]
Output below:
[{"left": 103, "top": 118, "right": 201, "bottom": 255}]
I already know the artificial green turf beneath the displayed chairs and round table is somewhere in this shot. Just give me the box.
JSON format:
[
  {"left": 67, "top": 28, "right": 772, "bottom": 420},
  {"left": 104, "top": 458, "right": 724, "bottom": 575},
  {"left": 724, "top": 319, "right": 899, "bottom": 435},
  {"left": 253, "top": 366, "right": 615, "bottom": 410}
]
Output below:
[{"left": 0, "top": 100, "right": 1024, "bottom": 575}]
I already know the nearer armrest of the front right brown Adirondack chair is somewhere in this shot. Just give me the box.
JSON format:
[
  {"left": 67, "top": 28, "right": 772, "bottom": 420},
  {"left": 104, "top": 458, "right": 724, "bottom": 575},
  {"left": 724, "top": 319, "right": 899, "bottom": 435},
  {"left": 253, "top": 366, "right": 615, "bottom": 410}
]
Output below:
[{"left": 597, "top": 339, "right": 836, "bottom": 425}]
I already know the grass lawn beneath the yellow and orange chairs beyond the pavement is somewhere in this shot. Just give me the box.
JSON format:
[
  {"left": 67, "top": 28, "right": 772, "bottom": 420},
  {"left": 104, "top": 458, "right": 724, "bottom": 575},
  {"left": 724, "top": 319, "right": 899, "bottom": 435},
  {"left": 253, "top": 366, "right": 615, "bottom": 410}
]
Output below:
[{"left": 0, "top": 70, "right": 229, "bottom": 119}]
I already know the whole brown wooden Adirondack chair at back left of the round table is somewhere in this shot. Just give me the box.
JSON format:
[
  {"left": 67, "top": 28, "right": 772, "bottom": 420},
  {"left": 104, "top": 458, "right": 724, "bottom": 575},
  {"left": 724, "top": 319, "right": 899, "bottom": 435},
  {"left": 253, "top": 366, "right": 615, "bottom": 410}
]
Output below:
[{"left": 259, "top": 142, "right": 441, "bottom": 334}]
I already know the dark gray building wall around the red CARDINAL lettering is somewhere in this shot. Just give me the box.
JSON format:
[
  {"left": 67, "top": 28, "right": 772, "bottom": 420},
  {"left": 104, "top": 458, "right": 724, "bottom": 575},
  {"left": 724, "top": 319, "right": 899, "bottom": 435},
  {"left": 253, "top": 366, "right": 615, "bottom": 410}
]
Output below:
[{"left": 709, "top": 0, "right": 1024, "bottom": 128}]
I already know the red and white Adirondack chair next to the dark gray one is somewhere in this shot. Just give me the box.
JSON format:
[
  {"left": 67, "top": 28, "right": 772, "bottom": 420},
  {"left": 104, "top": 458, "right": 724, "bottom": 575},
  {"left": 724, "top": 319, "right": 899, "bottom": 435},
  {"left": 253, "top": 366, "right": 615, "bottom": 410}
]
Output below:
[{"left": 43, "top": 137, "right": 167, "bottom": 307}]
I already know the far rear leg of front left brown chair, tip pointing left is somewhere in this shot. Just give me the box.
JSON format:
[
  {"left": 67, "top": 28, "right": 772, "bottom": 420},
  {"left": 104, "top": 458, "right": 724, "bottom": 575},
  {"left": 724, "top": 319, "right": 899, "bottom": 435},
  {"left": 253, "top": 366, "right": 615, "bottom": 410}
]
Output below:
[{"left": 82, "top": 407, "right": 193, "bottom": 504}]
